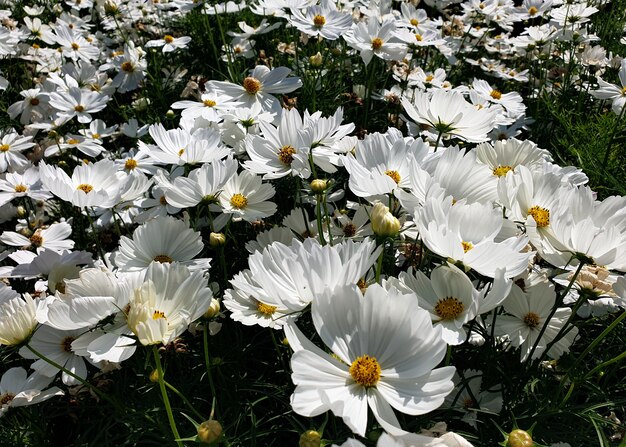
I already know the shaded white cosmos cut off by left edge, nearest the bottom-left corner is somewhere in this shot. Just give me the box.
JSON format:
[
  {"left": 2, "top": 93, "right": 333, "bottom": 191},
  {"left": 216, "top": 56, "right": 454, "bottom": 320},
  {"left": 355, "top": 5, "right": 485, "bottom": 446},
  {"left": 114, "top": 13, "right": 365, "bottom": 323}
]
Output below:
[{"left": 0, "top": 367, "right": 63, "bottom": 417}]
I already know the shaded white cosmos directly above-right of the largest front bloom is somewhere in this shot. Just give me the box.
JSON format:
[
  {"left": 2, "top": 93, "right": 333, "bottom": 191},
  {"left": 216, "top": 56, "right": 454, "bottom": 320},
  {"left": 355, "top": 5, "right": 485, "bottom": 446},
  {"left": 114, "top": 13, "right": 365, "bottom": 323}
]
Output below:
[{"left": 392, "top": 264, "right": 512, "bottom": 345}]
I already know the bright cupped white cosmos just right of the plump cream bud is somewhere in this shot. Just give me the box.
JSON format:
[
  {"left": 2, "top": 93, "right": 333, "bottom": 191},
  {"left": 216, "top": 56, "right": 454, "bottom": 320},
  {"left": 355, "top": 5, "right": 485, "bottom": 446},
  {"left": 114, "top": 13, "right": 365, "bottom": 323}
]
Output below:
[{"left": 416, "top": 196, "right": 534, "bottom": 278}]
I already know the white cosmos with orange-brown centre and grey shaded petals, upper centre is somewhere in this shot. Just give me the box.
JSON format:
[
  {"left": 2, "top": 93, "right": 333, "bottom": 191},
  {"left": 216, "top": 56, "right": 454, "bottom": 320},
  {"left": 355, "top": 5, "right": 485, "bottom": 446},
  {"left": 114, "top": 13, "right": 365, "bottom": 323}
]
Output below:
[{"left": 208, "top": 65, "right": 302, "bottom": 113}]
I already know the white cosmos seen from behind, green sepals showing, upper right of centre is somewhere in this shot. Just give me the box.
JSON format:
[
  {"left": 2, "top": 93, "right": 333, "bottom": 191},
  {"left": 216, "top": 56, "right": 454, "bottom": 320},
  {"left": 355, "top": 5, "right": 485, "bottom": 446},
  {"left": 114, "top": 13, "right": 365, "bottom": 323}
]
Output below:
[{"left": 402, "top": 89, "right": 495, "bottom": 143}]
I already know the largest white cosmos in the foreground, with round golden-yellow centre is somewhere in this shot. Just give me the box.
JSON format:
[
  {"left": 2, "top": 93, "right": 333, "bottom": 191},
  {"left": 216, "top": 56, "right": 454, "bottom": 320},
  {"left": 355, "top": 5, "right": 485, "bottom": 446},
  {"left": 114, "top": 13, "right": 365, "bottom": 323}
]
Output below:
[{"left": 285, "top": 284, "right": 454, "bottom": 436}]
